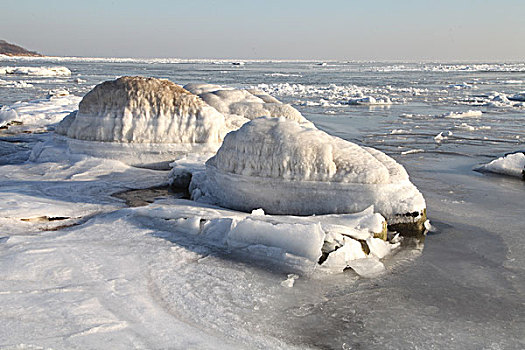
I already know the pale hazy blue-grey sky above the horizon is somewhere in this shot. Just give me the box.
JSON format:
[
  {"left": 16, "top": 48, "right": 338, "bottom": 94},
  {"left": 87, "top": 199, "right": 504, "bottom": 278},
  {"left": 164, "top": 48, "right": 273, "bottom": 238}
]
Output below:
[{"left": 0, "top": 0, "right": 525, "bottom": 61}]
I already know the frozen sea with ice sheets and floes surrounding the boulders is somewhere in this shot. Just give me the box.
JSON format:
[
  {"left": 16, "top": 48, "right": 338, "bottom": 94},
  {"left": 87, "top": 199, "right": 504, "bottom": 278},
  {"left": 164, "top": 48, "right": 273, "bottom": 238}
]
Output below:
[{"left": 0, "top": 57, "right": 525, "bottom": 349}]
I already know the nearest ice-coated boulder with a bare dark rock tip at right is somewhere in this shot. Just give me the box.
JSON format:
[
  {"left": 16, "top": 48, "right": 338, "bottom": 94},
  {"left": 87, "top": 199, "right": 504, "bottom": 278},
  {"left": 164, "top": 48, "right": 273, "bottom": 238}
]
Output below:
[{"left": 190, "top": 118, "right": 426, "bottom": 235}]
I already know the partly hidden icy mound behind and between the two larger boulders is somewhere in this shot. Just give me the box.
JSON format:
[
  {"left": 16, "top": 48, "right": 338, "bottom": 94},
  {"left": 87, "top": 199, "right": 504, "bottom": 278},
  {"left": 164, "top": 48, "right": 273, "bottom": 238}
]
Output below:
[{"left": 184, "top": 84, "right": 309, "bottom": 127}]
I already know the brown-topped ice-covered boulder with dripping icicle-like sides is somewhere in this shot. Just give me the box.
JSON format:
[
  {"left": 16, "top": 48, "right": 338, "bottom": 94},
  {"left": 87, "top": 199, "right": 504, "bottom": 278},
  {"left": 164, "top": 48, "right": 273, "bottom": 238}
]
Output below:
[{"left": 57, "top": 77, "right": 229, "bottom": 144}]
